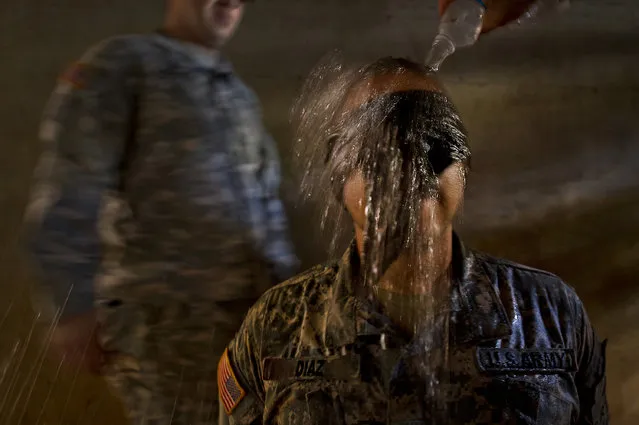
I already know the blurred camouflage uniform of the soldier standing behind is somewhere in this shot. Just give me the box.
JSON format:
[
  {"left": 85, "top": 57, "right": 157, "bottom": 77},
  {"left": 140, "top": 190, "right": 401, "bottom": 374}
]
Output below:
[{"left": 22, "top": 33, "right": 297, "bottom": 425}]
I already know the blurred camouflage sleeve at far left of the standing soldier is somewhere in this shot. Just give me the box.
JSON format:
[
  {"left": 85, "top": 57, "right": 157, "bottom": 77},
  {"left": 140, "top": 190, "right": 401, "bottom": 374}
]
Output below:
[{"left": 26, "top": 40, "right": 138, "bottom": 315}]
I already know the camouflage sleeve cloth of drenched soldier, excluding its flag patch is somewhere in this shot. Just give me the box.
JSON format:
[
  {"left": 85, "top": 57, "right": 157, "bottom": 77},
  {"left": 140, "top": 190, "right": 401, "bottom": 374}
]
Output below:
[{"left": 220, "top": 297, "right": 269, "bottom": 425}]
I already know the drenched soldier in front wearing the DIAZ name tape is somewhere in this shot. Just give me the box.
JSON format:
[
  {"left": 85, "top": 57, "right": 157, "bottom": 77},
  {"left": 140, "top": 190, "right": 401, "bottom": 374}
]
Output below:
[{"left": 218, "top": 58, "right": 608, "bottom": 425}]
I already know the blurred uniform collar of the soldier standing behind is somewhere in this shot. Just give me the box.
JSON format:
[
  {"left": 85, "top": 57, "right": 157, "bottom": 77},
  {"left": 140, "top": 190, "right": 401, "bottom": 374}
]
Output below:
[{"left": 155, "top": 30, "right": 233, "bottom": 74}]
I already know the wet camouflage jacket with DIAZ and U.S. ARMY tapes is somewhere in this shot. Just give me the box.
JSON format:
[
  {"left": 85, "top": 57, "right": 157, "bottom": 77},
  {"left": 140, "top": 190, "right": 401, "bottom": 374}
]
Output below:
[{"left": 218, "top": 238, "right": 608, "bottom": 425}]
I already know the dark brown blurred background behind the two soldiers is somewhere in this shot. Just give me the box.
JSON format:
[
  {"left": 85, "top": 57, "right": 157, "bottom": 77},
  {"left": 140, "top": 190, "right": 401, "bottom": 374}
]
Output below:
[{"left": 0, "top": 0, "right": 639, "bottom": 425}]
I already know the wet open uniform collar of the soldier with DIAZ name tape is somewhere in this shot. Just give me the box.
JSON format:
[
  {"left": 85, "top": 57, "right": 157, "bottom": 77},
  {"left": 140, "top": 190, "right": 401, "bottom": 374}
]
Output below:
[{"left": 325, "top": 233, "right": 511, "bottom": 347}]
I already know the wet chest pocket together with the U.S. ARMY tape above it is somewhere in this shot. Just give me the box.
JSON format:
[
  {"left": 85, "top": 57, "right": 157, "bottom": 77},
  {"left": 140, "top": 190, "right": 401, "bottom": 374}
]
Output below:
[{"left": 464, "top": 348, "right": 578, "bottom": 425}]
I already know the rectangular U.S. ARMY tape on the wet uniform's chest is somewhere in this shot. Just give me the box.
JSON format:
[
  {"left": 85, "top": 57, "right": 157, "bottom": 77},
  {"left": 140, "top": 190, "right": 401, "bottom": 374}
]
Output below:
[{"left": 477, "top": 347, "right": 577, "bottom": 374}]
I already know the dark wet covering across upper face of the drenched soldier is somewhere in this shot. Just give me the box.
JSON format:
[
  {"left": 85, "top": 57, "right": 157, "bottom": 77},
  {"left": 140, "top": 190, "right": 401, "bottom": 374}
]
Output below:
[{"left": 325, "top": 90, "right": 470, "bottom": 187}]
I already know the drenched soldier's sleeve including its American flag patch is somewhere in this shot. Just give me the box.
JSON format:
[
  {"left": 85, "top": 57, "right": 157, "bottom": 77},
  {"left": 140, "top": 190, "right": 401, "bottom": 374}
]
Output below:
[{"left": 218, "top": 299, "right": 266, "bottom": 425}]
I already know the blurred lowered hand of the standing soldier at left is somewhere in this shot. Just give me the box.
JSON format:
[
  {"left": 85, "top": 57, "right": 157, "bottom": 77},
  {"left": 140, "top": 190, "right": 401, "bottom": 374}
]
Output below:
[{"left": 49, "top": 310, "right": 106, "bottom": 374}]
